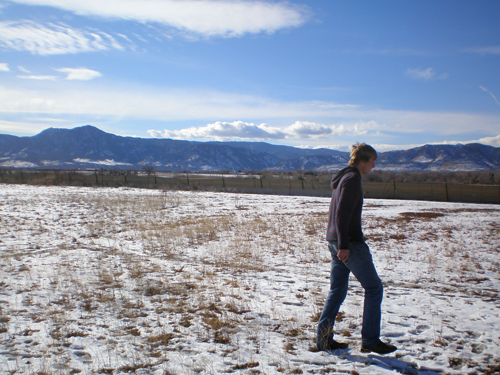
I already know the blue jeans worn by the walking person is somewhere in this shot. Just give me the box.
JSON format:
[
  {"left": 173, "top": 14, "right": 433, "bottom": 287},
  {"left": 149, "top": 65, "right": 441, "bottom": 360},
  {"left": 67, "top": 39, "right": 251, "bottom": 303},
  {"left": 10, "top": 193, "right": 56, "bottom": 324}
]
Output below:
[{"left": 316, "top": 241, "right": 384, "bottom": 350}]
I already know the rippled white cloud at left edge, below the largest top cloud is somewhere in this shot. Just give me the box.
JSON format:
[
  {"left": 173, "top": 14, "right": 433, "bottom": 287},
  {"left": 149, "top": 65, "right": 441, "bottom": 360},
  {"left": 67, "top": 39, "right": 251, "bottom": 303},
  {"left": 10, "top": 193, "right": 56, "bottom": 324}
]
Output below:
[{"left": 0, "top": 21, "right": 123, "bottom": 55}]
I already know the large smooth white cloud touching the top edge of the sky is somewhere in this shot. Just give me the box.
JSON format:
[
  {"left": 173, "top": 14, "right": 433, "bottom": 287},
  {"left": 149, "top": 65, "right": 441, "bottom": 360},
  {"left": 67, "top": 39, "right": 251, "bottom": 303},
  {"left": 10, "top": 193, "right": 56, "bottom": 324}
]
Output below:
[{"left": 12, "top": 0, "right": 308, "bottom": 36}]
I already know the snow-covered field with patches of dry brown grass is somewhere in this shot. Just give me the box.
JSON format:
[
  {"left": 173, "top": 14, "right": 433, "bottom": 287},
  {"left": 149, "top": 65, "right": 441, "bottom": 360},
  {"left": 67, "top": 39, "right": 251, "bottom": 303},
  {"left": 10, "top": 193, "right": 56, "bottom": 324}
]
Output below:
[{"left": 0, "top": 185, "right": 500, "bottom": 375}]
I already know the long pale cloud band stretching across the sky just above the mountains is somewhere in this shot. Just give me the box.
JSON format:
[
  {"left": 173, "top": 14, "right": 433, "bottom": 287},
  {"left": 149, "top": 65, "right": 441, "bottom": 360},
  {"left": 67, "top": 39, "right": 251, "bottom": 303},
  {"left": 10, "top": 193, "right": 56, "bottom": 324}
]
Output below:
[{"left": 0, "top": 84, "right": 500, "bottom": 140}]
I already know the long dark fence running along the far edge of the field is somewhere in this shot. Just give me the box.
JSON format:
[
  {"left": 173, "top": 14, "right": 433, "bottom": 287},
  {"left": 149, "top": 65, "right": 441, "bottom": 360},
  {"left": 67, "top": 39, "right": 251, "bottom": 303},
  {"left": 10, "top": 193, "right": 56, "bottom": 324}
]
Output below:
[{"left": 0, "top": 170, "right": 500, "bottom": 204}]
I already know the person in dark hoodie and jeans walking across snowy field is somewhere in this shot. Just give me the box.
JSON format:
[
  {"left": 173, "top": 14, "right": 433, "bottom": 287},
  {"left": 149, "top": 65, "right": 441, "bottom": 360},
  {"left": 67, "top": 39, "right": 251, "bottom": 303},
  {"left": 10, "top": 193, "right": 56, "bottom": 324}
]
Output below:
[{"left": 316, "top": 143, "right": 397, "bottom": 354}]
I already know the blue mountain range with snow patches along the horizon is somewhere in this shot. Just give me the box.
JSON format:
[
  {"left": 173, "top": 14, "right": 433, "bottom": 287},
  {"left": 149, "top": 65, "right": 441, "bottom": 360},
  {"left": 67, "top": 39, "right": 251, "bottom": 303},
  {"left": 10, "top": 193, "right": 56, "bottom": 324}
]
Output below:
[{"left": 0, "top": 125, "right": 500, "bottom": 172}]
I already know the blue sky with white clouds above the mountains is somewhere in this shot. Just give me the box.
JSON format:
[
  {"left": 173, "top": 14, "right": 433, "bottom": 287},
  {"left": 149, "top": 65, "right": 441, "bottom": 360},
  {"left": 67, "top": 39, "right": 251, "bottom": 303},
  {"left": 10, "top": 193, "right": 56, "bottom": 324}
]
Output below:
[{"left": 0, "top": 0, "right": 500, "bottom": 151}]
